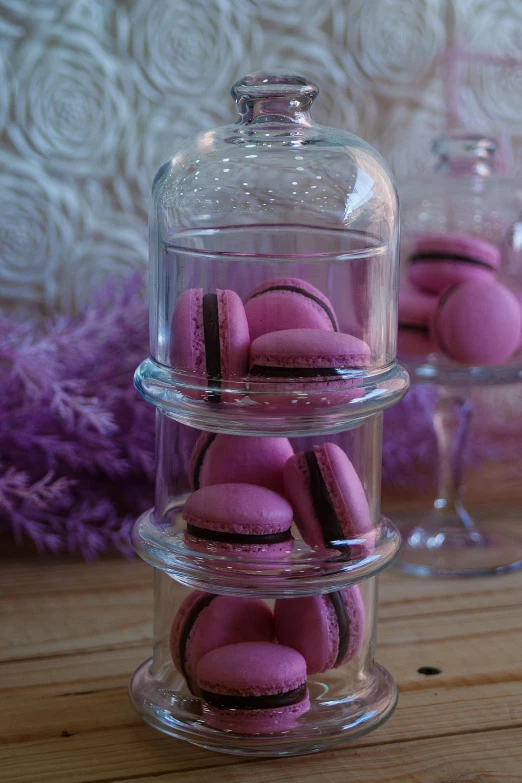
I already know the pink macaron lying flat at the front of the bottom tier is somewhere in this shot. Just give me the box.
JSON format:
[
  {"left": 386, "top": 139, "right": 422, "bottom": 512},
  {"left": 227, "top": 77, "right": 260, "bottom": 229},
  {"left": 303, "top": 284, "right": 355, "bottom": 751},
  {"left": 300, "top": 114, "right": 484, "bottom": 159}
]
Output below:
[{"left": 197, "top": 642, "right": 310, "bottom": 734}]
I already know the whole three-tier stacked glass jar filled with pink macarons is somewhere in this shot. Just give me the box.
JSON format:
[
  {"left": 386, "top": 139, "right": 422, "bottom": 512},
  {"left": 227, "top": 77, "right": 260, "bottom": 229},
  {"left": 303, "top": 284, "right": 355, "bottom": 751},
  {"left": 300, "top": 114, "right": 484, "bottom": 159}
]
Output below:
[{"left": 131, "top": 73, "right": 408, "bottom": 755}]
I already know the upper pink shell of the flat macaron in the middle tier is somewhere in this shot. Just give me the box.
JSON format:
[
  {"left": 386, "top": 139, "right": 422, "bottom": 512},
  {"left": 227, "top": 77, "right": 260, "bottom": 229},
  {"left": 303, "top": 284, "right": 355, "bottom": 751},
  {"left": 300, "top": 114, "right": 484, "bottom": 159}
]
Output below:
[{"left": 183, "top": 484, "right": 293, "bottom": 535}]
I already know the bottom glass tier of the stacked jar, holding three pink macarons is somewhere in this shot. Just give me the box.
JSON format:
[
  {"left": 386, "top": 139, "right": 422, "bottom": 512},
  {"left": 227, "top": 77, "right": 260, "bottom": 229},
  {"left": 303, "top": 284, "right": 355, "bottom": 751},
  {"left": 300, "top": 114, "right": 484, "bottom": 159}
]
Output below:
[{"left": 130, "top": 569, "right": 397, "bottom": 756}]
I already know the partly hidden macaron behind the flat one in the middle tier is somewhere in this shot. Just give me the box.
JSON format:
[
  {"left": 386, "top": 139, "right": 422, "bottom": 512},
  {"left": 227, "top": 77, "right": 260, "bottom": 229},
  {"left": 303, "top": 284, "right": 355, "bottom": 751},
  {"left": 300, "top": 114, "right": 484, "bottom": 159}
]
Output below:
[{"left": 189, "top": 432, "right": 294, "bottom": 493}]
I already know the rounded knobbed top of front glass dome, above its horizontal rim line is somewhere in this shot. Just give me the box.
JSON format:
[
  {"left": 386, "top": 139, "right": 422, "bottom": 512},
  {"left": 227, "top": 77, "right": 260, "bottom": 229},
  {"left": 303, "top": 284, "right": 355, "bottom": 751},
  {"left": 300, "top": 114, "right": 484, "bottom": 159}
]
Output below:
[{"left": 153, "top": 71, "right": 398, "bottom": 245}]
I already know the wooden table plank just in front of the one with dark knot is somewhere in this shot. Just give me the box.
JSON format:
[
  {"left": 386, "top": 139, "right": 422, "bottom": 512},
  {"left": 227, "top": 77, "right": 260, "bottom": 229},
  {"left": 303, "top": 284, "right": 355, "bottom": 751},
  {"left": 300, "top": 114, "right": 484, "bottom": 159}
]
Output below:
[{"left": 0, "top": 681, "right": 522, "bottom": 745}]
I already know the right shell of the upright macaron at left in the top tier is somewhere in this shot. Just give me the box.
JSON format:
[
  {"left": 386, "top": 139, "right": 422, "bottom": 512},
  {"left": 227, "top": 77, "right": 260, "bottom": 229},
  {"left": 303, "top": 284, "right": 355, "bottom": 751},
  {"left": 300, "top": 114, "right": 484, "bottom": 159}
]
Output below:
[{"left": 217, "top": 289, "right": 250, "bottom": 379}]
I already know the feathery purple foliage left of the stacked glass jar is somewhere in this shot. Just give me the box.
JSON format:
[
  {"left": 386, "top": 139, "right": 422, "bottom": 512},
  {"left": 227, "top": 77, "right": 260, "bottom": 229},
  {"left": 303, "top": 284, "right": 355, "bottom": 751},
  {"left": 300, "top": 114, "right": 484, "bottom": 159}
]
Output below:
[{"left": 0, "top": 275, "right": 154, "bottom": 559}]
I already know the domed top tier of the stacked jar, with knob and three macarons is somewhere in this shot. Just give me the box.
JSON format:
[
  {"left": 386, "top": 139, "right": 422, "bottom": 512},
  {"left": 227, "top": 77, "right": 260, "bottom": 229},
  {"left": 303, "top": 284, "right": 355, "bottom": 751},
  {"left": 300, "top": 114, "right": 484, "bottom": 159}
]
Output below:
[{"left": 136, "top": 73, "right": 407, "bottom": 435}]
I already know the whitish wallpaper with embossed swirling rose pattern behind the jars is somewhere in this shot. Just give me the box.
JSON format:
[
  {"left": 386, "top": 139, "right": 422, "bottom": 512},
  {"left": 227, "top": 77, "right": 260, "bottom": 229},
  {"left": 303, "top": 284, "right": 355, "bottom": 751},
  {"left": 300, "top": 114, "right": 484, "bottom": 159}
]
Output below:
[{"left": 0, "top": 0, "right": 522, "bottom": 317}]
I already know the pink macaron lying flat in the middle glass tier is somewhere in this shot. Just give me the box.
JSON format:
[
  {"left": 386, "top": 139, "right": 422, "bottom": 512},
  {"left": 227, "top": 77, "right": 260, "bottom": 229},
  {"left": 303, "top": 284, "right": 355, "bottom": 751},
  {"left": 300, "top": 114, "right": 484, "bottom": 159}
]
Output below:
[{"left": 183, "top": 484, "right": 294, "bottom": 560}]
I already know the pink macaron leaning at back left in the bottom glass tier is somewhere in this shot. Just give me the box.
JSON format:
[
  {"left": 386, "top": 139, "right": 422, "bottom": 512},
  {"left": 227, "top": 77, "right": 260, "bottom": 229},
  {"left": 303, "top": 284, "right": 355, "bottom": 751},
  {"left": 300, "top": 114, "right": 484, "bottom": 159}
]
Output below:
[{"left": 170, "top": 590, "right": 274, "bottom": 695}]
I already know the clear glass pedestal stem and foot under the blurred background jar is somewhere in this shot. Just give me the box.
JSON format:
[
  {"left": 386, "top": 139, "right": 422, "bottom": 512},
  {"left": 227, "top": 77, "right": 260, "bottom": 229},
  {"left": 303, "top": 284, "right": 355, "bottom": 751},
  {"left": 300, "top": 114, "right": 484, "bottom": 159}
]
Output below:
[{"left": 396, "top": 360, "right": 522, "bottom": 577}]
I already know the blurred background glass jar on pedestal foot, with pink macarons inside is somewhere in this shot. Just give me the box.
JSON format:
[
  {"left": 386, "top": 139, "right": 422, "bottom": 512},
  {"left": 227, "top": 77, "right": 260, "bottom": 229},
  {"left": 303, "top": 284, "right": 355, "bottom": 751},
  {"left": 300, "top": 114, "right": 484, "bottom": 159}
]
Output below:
[{"left": 398, "top": 131, "right": 522, "bottom": 576}]
